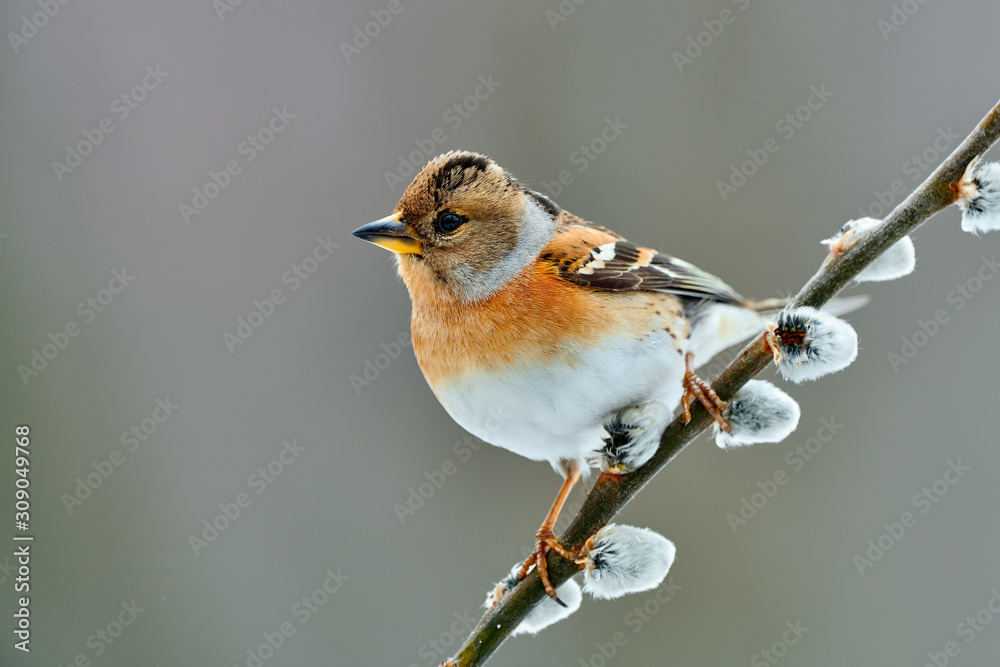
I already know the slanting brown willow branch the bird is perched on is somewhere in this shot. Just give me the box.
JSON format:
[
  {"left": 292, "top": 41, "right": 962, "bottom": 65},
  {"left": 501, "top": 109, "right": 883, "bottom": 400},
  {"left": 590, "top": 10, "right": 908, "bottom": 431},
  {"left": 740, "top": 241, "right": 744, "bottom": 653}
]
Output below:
[{"left": 444, "top": 95, "right": 1000, "bottom": 667}]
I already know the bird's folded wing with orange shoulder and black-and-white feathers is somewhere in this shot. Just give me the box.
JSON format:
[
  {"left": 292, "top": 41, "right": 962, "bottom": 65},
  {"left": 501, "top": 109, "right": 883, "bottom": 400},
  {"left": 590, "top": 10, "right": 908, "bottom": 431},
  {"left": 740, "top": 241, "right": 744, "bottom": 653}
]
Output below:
[{"left": 539, "top": 219, "right": 743, "bottom": 304}]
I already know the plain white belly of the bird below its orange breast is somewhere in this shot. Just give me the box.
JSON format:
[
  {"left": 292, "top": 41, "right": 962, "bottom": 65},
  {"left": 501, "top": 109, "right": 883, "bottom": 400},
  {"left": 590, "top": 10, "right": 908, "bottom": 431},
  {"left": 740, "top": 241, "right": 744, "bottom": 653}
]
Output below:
[{"left": 436, "top": 332, "right": 684, "bottom": 462}]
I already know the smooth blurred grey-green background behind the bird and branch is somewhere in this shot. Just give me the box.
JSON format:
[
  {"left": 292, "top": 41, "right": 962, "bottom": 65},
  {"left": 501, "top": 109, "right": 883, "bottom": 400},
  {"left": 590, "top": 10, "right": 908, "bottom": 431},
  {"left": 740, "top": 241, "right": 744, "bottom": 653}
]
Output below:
[{"left": 0, "top": 0, "right": 1000, "bottom": 667}]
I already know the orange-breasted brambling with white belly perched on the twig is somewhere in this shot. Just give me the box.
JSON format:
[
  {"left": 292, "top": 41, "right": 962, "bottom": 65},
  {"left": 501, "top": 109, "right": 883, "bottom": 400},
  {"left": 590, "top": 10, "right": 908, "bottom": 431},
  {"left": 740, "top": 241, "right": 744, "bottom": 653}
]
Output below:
[{"left": 353, "top": 151, "right": 784, "bottom": 601}]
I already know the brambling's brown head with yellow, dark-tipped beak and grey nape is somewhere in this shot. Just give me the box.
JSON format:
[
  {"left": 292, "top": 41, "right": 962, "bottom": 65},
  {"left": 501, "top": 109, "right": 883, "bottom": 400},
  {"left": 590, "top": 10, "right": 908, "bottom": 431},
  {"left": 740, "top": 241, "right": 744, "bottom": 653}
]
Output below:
[{"left": 353, "top": 151, "right": 559, "bottom": 301}]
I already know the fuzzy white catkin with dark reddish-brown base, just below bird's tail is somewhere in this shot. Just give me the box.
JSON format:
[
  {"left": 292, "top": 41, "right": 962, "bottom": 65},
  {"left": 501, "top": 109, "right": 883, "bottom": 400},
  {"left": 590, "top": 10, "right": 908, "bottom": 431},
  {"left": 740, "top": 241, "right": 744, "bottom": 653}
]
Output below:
[{"left": 777, "top": 306, "right": 858, "bottom": 383}]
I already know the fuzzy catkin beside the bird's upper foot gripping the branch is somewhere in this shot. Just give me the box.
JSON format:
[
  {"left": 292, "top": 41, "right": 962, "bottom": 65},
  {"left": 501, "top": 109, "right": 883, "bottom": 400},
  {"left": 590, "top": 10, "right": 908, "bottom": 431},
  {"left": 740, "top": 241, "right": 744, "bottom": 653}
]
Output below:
[{"left": 714, "top": 380, "right": 801, "bottom": 449}]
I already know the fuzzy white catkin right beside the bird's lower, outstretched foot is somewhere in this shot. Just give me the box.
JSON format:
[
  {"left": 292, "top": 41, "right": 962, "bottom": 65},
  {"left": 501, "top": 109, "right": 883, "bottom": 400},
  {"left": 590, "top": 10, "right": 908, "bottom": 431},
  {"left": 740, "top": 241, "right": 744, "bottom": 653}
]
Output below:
[{"left": 583, "top": 523, "right": 677, "bottom": 600}]
